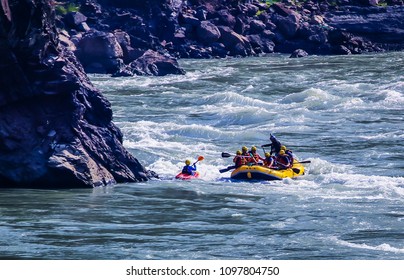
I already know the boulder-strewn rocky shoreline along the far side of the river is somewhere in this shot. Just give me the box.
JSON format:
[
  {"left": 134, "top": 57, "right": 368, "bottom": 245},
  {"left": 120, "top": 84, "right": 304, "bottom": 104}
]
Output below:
[{"left": 54, "top": 0, "right": 404, "bottom": 76}]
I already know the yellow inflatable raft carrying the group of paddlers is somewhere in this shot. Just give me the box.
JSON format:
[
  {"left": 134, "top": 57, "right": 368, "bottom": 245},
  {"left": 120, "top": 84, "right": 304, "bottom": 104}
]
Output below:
[{"left": 230, "top": 160, "right": 304, "bottom": 181}]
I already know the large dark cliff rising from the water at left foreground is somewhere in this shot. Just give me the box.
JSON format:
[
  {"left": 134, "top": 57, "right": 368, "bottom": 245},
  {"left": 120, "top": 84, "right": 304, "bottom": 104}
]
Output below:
[{"left": 0, "top": 0, "right": 155, "bottom": 188}]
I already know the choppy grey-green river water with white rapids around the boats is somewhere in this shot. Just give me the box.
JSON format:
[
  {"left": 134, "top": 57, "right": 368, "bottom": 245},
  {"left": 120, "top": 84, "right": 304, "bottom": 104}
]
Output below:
[{"left": 0, "top": 53, "right": 404, "bottom": 260}]
